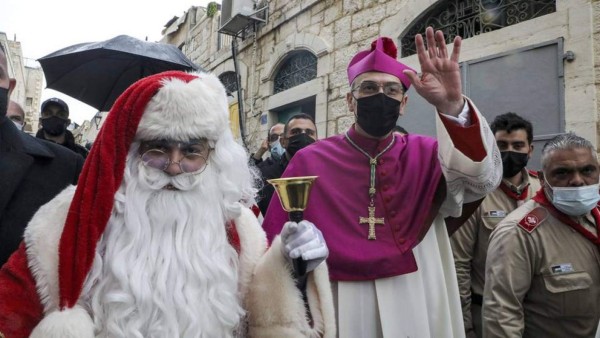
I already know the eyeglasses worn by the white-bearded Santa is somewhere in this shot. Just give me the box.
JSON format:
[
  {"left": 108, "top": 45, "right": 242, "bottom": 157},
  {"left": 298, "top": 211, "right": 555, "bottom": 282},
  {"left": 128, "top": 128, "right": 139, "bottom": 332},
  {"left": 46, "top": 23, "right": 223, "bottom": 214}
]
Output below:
[{"left": 139, "top": 139, "right": 212, "bottom": 173}]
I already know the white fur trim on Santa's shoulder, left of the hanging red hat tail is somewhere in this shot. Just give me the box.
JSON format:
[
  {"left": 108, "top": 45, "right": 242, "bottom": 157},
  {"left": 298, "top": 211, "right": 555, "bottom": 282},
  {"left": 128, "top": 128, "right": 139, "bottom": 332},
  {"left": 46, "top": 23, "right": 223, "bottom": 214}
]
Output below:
[{"left": 23, "top": 186, "right": 76, "bottom": 313}]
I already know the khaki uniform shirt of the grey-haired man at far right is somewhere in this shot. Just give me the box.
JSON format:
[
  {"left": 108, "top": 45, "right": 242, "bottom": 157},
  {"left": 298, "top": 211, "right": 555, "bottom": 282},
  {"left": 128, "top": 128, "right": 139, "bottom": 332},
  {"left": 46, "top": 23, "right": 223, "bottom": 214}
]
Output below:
[{"left": 483, "top": 201, "right": 600, "bottom": 338}]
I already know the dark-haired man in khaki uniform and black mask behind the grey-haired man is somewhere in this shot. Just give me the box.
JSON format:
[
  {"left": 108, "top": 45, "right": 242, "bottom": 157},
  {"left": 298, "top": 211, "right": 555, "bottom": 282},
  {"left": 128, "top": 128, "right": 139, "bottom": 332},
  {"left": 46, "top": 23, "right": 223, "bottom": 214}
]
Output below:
[{"left": 450, "top": 113, "right": 540, "bottom": 337}]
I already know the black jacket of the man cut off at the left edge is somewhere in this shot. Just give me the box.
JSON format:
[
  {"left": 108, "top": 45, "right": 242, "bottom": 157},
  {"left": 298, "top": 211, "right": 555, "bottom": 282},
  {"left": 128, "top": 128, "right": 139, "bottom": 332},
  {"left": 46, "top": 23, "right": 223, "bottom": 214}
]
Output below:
[{"left": 0, "top": 116, "right": 83, "bottom": 266}]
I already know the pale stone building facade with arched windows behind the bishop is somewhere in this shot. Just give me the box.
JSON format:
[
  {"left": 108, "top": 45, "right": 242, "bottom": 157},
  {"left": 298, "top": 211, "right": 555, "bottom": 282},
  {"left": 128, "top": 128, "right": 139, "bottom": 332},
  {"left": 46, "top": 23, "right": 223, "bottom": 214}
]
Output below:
[{"left": 164, "top": 0, "right": 600, "bottom": 169}]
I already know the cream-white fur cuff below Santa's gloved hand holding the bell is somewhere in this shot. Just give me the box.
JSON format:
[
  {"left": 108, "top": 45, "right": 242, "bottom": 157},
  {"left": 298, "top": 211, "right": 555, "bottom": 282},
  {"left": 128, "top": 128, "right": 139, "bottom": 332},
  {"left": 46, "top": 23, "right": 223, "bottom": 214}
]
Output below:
[{"left": 246, "top": 236, "right": 336, "bottom": 338}]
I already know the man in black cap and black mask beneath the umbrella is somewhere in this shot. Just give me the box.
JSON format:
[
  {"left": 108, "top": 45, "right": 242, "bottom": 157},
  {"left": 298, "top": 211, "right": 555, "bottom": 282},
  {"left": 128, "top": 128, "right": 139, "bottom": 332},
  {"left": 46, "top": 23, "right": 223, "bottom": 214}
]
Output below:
[{"left": 35, "top": 97, "right": 88, "bottom": 159}]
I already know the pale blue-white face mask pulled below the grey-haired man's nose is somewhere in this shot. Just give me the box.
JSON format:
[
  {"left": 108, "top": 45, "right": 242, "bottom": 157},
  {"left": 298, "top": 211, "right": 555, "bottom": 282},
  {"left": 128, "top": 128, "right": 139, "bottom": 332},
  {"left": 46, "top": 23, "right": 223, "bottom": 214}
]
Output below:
[{"left": 546, "top": 182, "right": 600, "bottom": 216}]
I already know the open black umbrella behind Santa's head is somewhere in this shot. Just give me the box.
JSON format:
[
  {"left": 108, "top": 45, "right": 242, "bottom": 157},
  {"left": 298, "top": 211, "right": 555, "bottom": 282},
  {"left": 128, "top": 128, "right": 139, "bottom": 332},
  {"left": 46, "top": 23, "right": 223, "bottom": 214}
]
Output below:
[{"left": 38, "top": 35, "right": 199, "bottom": 111}]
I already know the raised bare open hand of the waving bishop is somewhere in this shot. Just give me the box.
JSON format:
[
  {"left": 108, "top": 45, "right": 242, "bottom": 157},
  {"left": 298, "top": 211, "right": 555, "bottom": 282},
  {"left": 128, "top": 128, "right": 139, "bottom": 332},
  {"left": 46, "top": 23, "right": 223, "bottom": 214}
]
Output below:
[{"left": 404, "top": 27, "right": 464, "bottom": 116}]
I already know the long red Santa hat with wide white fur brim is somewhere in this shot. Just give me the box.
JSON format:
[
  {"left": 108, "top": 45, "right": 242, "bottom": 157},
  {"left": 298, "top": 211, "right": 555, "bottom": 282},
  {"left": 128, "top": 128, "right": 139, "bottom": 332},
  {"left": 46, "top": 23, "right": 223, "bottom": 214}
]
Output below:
[{"left": 58, "top": 71, "right": 229, "bottom": 310}]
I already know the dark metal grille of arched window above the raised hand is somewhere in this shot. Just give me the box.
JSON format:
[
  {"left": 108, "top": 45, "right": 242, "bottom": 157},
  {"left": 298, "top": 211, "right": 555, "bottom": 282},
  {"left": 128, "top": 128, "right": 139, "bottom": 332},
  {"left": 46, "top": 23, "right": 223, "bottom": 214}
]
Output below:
[{"left": 400, "top": 0, "right": 556, "bottom": 57}]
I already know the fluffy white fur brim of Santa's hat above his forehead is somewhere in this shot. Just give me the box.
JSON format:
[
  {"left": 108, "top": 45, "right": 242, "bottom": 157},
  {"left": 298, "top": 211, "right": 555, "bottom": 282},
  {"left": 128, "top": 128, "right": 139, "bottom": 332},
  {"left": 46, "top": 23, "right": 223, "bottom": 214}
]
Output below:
[{"left": 136, "top": 73, "right": 229, "bottom": 140}]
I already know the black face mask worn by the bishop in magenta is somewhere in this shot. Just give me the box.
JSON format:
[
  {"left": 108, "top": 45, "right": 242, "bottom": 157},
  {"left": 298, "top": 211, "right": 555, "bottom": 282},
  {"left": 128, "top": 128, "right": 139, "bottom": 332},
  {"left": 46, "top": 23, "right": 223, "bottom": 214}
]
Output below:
[{"left": 356, "top": 93, "right": 401, "bottom": 137}]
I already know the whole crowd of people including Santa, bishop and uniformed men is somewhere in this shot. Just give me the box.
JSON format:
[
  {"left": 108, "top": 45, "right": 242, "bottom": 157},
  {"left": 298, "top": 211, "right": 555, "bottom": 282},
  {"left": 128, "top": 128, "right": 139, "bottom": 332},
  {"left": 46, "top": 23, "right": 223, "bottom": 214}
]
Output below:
[{"left": 0, "top": 28, "right": 600, "bottom": 338}]
